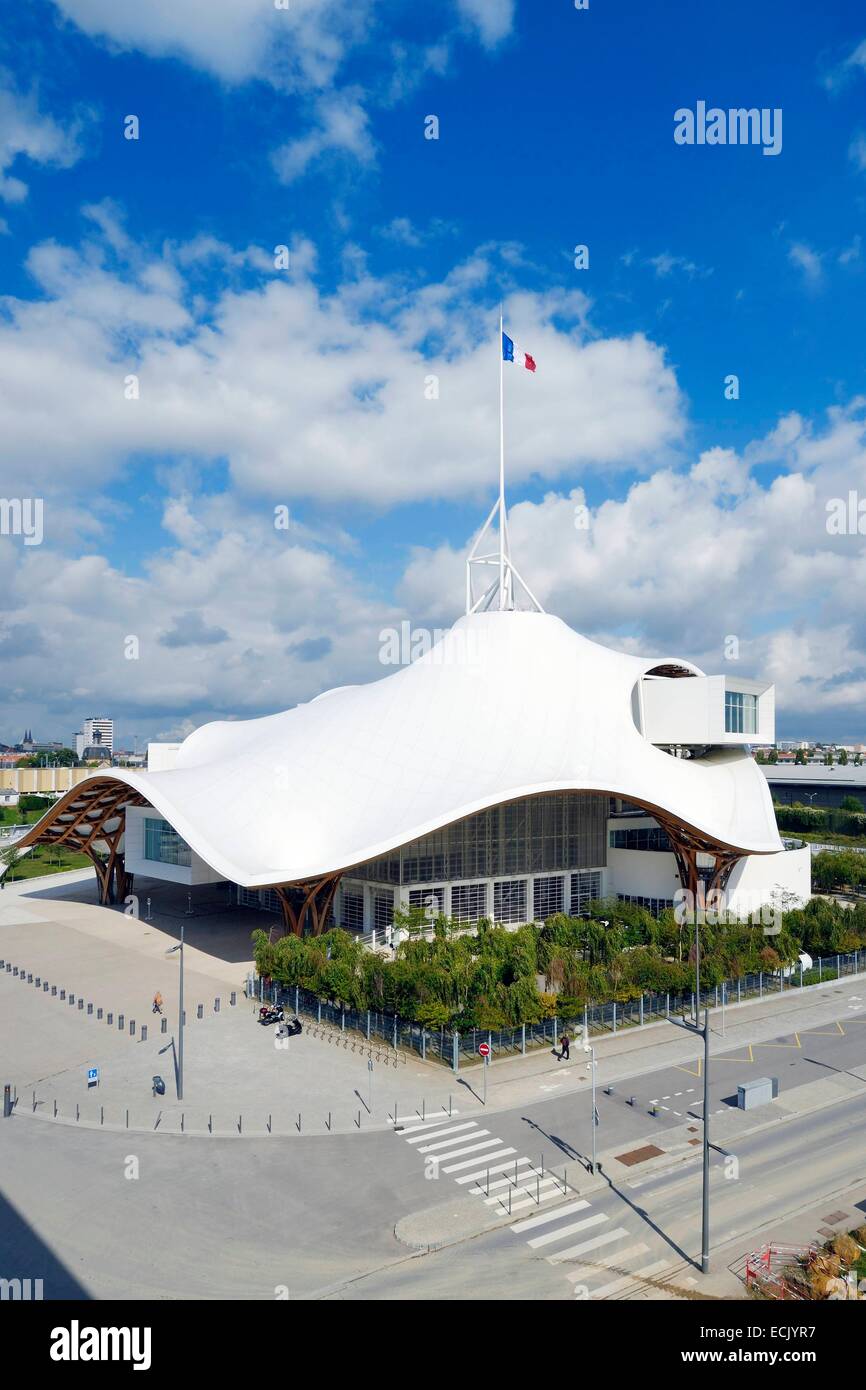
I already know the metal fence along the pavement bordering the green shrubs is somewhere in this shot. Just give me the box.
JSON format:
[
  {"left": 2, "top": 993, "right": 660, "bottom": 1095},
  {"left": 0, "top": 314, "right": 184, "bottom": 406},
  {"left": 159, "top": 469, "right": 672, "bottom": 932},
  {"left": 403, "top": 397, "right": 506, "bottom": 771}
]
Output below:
[{"left": 246, "top": 951, "right": 866, "bottom": 1072}]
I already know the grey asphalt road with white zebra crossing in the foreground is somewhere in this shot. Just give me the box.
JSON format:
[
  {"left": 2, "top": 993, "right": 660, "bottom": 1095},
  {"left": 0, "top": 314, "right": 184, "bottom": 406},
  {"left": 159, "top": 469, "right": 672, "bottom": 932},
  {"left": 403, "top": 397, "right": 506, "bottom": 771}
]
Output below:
[{"left": 0, "top": 999, "right": 866, "bottom": 1300}]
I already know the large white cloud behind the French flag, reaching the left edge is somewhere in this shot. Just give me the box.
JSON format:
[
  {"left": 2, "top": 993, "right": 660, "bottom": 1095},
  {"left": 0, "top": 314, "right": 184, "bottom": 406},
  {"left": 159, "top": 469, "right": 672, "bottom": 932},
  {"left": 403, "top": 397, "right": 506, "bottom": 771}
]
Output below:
[{"left": 0, "top": 214, "right": 684, "bottom": 506}]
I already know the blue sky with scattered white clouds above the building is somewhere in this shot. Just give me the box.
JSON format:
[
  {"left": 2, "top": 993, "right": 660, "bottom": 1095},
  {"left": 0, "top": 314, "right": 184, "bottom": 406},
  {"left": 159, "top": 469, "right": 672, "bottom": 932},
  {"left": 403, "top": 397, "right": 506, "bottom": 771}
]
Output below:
[{"left": 0, "top": 0, "right": 866, "bottom": 742}]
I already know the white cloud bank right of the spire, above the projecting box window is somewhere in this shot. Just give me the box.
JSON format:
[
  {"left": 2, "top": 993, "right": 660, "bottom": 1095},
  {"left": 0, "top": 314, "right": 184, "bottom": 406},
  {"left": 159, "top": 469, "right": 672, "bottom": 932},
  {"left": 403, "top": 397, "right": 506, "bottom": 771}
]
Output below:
[{"left": 399, "top": 399, "right": 866, "bottom": 735}]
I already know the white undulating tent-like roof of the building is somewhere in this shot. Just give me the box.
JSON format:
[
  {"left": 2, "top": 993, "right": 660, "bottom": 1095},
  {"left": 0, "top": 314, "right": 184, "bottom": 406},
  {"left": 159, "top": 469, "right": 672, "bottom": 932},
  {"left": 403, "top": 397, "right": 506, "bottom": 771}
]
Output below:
[{"left": 44, "top": 612, "right": 781, "bottom": 887}]
